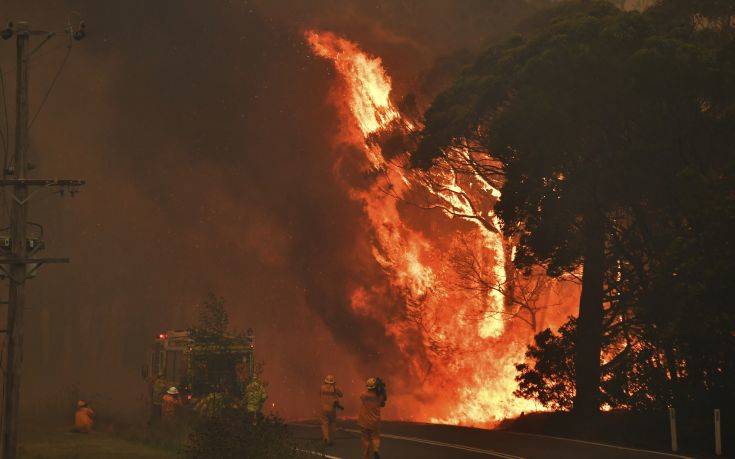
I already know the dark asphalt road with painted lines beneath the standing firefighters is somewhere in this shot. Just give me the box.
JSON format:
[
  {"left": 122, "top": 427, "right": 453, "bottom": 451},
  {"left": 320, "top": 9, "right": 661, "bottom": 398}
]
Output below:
[{"left": 291, "top": 421, "right": 688, "bottom": 459}]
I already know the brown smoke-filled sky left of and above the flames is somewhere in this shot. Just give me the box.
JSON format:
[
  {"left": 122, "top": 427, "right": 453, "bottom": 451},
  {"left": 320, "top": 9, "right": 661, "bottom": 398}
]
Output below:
[{"left": 0, "top": 0, "right": 544, "bottom": 416}]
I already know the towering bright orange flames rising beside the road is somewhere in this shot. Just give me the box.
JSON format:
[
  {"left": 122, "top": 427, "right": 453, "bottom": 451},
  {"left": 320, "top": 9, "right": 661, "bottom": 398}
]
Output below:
[{"left": 306, "top": 31, "right": 576, "bottom": 425}]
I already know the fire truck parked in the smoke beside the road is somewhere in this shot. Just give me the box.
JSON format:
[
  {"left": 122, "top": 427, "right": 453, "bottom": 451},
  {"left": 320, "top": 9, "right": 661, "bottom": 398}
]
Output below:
[{"left": 141, "top": 329, "right": 255, "bottom": 415}]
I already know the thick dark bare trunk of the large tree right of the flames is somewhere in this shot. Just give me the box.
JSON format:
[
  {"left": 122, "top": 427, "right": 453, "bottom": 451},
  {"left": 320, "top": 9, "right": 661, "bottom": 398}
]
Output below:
[{"left": 573, "top": 223, "right": 605, "bottom": 416}]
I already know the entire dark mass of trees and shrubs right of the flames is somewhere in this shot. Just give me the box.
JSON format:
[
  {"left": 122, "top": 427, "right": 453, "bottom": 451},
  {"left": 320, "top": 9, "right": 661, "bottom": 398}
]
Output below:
[{"left": 414, "top": 0, "right": 735, "bottom": 416}]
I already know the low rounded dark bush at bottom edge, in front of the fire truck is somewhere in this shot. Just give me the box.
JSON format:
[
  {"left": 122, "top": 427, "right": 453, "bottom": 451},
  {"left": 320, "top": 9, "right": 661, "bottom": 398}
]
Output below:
[{"left": 185, "top": 409, "right": 309, "bottom": 459}]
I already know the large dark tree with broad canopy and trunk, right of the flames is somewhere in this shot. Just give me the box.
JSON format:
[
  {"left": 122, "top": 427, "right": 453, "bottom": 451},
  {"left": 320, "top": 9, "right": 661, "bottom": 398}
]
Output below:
[{"left": 414, "top": 1, "right": 732, "bottom": 414}]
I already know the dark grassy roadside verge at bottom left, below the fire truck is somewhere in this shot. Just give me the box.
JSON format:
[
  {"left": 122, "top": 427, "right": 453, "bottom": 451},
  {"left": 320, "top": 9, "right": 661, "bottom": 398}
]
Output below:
[{"left": 19, "top": 390, "right": 322, "bottom": 459}]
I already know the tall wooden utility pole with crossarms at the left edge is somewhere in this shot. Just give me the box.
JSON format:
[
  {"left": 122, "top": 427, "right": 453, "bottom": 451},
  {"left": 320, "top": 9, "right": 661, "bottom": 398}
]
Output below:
[{"left": 0, "top": 22, "right": 84, "bottom": 459}]
